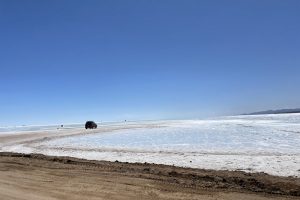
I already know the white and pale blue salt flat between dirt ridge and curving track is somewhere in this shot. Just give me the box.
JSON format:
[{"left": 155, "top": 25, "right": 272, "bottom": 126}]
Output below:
[{"left": 3, "top": 114, "right": 300, "bottom": 177}]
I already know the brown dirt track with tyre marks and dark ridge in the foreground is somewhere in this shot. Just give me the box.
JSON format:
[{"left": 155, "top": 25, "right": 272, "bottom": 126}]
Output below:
[{"left": 0, "top": 152, "right": 300, "bottom": 200}]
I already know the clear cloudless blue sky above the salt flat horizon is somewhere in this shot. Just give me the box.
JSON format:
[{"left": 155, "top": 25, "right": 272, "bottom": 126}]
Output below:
[{"left": 0, "top": 0, "right": 300, "bottom": 125}]
